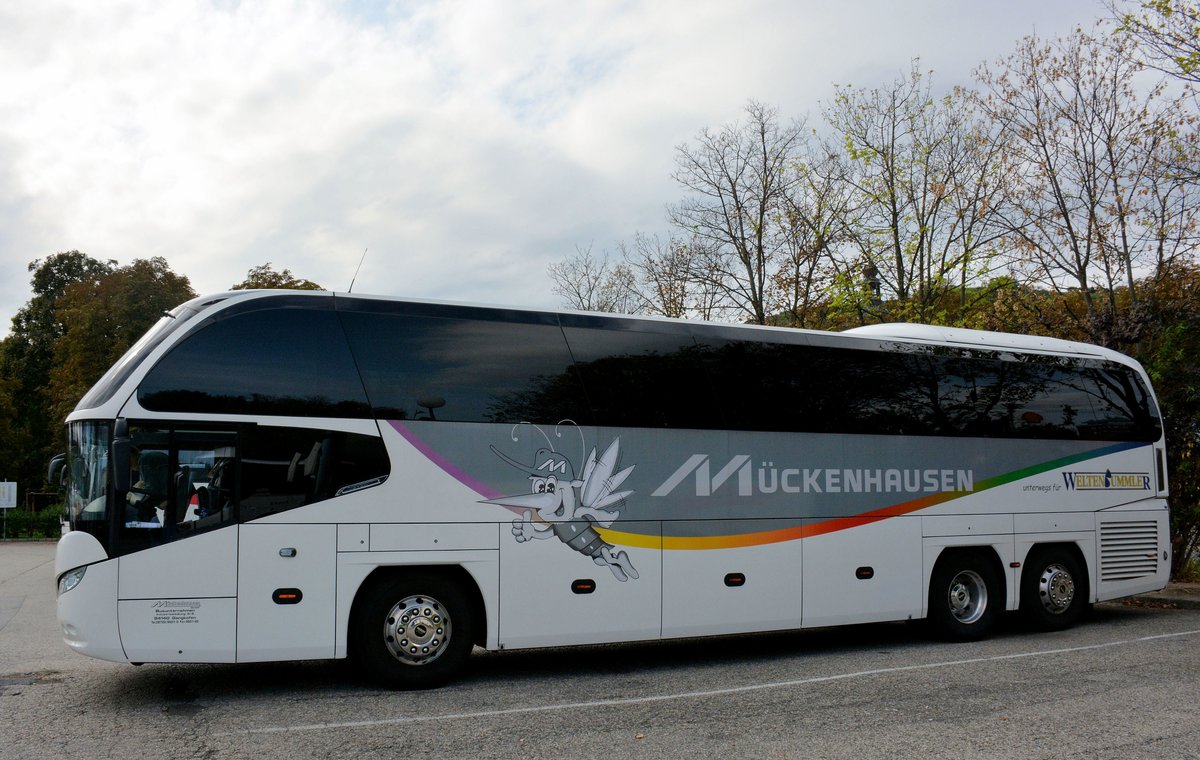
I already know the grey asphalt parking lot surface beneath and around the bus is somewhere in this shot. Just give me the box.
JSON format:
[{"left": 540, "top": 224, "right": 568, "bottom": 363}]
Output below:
[{"left": 0, "top": 543, "right": 1200, "bottom": 759}]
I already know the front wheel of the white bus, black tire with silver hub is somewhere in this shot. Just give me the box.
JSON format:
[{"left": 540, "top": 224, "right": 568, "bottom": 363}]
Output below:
[{"left": 350, "top": 573, "right": 475, "bottom": 689}]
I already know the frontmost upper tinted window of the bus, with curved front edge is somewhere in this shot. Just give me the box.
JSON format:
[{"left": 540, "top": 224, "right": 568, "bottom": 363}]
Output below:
[{"left": 138, "top": 309, "right": 370, "bottom": 418}]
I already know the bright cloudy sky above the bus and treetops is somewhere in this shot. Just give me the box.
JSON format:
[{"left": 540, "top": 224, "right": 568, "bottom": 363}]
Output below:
[{"left": 0, "top": 0, "right": 1104, "bottom": 334}]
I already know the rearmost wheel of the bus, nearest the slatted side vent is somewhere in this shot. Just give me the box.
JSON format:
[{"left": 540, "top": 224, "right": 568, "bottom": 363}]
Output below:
[{"left": 1021, "top": 546, "right": 1087, "bottom": 630}]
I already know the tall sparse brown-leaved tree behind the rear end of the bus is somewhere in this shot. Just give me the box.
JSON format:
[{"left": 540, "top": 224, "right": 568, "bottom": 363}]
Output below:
[{"left": 977, "top": 30, "right": 1200, "bottom": 346}]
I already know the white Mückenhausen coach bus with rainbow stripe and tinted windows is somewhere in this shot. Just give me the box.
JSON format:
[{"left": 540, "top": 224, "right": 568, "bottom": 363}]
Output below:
[{"left": 55, "top": 291, "right": 1170, "bottom": 687}]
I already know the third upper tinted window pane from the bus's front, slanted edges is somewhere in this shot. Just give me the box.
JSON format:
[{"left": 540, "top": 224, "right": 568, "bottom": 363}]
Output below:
[{"left": 563, "top": 327, "right": 725, "bottom": 429}]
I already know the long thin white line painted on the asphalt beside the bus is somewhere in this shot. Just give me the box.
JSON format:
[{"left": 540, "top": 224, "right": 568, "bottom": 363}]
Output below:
[{"left": 214, "top": 629, "right": 1200, "bottom": 736}]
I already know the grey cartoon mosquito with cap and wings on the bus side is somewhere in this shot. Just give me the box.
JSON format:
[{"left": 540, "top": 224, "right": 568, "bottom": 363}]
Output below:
[{"left": 485, "top": 420, "right": 637, "bottom": 581}]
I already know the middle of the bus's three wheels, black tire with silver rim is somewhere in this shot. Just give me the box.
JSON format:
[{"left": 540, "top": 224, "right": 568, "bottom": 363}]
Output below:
[{"left": 929, "top": 551, "right": 1004, "bottom": 641}]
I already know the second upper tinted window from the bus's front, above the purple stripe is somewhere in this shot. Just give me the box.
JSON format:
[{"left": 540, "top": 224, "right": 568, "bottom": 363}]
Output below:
[{"left": 342, "top": 311, "right": 587, "bottom": 424}]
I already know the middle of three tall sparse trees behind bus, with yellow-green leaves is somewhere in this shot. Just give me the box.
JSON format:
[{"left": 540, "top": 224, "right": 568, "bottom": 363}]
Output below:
[{"left": 824, "top": 61, "right": 1000, "bottom": 321}]
